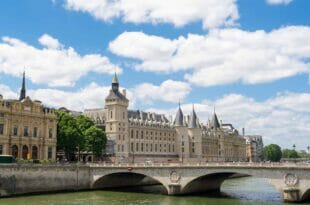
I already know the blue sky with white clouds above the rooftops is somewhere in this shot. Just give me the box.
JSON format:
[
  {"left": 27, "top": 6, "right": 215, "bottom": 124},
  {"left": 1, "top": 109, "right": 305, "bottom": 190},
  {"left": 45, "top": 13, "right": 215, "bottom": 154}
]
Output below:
[{"left": 0, "top": 0, "right": 310, "bottom": 150}]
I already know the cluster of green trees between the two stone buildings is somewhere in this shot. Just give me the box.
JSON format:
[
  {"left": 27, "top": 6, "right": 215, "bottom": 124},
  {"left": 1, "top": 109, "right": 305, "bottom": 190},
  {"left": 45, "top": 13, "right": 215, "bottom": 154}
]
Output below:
[{"left": 56, "top": 111, "right": 106, "bottom": 161}]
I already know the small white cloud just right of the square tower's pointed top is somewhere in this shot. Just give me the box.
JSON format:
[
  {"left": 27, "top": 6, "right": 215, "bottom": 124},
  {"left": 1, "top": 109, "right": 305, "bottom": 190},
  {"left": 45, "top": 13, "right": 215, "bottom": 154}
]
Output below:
[{"left": 131, "top": 80, "right": 191, "bottom": 104}]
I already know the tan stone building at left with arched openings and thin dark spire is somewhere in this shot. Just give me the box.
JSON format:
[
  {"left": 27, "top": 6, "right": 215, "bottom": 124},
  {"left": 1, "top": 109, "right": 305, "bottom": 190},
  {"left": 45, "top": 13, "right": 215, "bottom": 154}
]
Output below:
[{"left": 0, "top": 74, "right": 57, "bottom": 160}]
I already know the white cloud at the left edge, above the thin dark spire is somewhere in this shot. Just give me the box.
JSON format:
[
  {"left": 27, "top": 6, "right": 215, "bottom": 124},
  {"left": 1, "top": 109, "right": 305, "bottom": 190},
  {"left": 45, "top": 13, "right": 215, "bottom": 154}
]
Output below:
[{"left": 0, "top": 34, "right": 121, "bottom": 86}]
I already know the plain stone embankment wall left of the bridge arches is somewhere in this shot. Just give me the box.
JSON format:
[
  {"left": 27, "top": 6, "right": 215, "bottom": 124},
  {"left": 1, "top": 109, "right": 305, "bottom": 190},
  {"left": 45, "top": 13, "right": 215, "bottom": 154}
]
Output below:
[{"left": 0, "top": 164, "right": 90, "bottom": 196}]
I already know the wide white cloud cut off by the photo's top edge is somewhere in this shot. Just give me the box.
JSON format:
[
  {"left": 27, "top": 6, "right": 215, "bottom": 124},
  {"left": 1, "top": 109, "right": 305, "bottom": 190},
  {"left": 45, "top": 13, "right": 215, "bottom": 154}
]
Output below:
[{"left": 65, "top": 0, "right": 239, "bottom": 28}]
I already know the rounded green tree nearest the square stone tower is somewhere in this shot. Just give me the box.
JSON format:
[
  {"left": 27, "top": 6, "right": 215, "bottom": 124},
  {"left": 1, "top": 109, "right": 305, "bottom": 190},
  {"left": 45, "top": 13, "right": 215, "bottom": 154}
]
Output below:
[{"left": 85, "top": 126, "right": 107, "bottom": 156}]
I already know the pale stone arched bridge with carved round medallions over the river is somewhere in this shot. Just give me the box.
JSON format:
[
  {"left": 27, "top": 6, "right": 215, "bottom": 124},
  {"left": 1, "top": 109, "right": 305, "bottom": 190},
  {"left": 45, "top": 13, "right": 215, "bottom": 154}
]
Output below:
[{"left": 91, "top": 163, "right": 310, "bottom": 202}]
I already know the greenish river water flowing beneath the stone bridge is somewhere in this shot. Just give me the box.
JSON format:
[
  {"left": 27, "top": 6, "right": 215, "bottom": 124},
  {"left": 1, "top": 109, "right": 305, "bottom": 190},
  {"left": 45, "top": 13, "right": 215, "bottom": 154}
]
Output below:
[{"left": 0, "top": 177, "right": 310, "bottom": 205}]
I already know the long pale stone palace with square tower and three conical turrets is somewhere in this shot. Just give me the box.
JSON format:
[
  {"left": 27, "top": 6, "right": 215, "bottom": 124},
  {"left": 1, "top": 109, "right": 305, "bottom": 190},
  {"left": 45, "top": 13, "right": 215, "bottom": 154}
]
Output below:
[{"left": 84, "top": 74, "right": 246, "bottom": 162}]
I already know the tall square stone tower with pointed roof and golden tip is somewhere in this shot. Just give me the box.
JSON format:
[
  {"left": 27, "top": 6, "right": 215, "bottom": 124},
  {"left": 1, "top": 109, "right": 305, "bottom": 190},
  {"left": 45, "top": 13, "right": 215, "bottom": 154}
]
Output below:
[{"left": 105, "top": 73, "right": 129, "bottom": 162}]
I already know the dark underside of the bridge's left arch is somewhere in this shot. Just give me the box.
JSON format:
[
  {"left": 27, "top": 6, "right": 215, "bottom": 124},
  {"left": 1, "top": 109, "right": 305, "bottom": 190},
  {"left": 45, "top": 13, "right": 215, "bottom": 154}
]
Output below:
[{"left": 92, "top": 171, "right": 168, "bottom": 194}]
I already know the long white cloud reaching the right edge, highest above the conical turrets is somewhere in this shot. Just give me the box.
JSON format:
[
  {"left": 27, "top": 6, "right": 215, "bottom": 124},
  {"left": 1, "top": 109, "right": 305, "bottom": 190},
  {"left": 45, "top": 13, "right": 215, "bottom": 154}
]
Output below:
[{"left": 109, "top": 26, "right": 310, "bottom": 86}]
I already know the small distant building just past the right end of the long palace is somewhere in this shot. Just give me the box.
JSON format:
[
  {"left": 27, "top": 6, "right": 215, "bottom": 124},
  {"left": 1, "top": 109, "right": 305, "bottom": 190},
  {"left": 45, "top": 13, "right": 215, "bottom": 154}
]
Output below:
[{"left": 245, "top": 135, "right": 264, "bottom": 162}]
